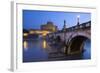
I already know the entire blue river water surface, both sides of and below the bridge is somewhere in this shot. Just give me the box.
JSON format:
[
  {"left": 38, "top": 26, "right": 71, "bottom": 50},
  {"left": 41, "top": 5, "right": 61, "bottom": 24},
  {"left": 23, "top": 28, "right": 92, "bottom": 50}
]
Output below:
[{"left": 23, "top": 38, "right": 91, "bottom": 62}]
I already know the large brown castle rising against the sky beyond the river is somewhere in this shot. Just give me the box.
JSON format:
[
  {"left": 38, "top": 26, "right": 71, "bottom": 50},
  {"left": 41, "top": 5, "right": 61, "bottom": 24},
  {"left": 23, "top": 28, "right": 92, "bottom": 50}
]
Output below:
[{"left": 41, "top": 21, "right": 57, "bottom": 32}]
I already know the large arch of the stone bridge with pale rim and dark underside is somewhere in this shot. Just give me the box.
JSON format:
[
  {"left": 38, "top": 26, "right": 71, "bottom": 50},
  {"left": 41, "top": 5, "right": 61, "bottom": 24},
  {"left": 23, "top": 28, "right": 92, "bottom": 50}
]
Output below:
[{"left": 67, "top": 33, "right": 91, "bottom": 54}]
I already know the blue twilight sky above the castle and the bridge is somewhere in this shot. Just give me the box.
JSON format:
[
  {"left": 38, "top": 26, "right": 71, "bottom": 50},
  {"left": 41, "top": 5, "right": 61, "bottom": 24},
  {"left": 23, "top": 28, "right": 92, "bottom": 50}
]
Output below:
[{"left": 23, "top": 10, "right": 91, "bottom": 29}]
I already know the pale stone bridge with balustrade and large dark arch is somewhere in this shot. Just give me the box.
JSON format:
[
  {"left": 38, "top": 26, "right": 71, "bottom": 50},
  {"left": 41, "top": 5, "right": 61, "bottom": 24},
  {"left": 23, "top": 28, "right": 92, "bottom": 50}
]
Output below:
[{"left": 48, "top": 21, "right": 91, "bottom": 54}]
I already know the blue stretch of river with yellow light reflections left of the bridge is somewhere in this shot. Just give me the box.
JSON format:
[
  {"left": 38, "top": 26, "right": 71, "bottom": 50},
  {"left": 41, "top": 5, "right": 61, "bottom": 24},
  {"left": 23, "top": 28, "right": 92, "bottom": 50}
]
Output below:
[{"left": 23, "top": 39, "right": 48, "bottom": 62}]
